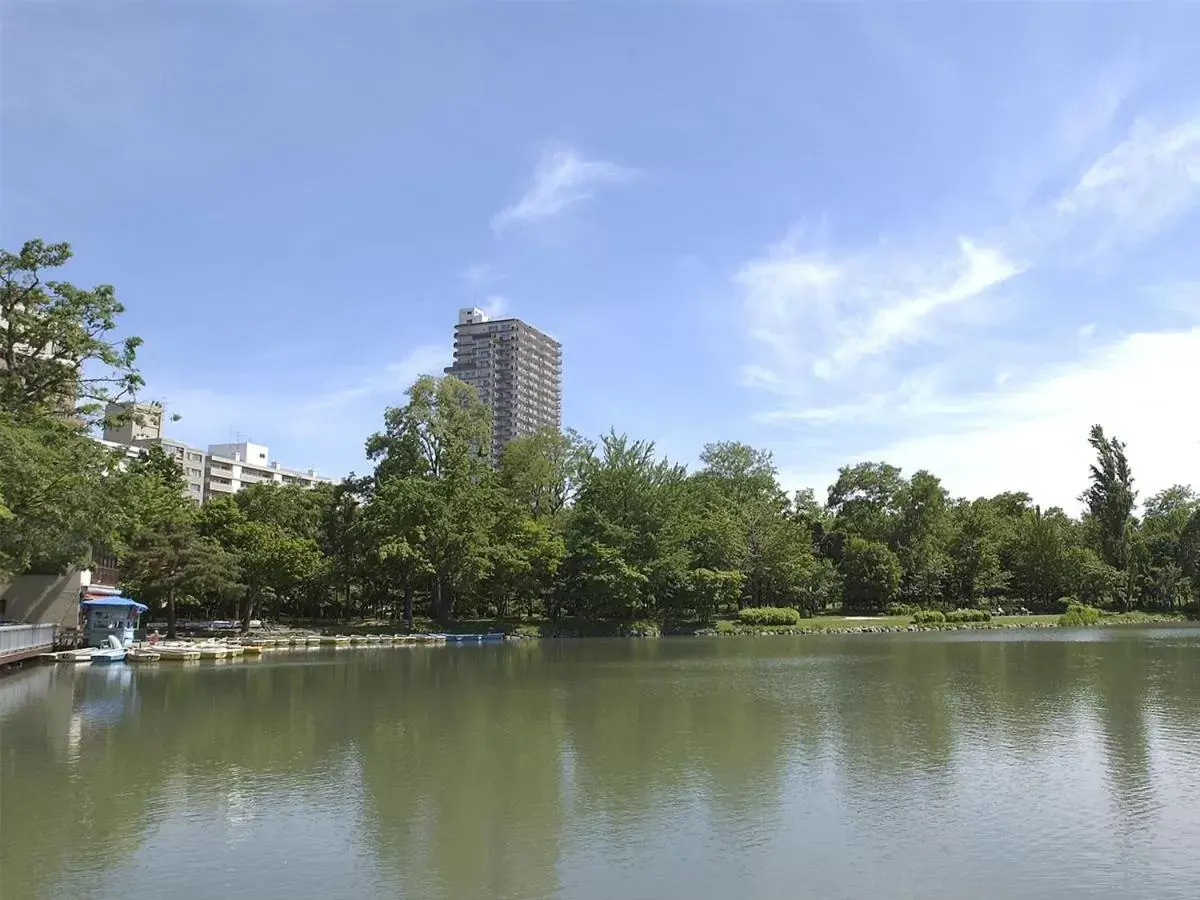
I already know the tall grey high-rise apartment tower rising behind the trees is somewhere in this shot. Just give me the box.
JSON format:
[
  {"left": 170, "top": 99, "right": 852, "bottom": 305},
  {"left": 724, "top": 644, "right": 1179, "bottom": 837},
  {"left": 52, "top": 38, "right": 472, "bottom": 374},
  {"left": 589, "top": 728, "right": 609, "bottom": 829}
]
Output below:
[{"left": 445, "top": 308, "right": 563, "bottom": 461}]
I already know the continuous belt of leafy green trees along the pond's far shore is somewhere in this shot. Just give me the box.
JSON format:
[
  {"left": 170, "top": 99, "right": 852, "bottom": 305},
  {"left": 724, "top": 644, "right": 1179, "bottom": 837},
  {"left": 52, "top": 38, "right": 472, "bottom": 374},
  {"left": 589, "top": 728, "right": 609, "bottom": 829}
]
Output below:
[{"left": 7, "top": 242, "right": 1200, "bottom": 623}]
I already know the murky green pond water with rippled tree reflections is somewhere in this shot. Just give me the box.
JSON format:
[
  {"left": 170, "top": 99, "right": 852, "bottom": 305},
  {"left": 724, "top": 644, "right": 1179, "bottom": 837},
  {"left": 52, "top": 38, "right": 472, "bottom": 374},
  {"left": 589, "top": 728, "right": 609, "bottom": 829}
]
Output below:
[{"left": 0, "top": 629, "right": 1200, "bottom": 900}]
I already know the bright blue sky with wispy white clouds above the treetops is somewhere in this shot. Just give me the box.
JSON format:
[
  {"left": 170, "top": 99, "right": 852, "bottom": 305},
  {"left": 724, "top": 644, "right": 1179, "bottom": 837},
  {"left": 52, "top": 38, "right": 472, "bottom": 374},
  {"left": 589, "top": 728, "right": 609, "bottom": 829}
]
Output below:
[{"left": 0, "top": 0, "right": 1200, "bottom": 509}]
